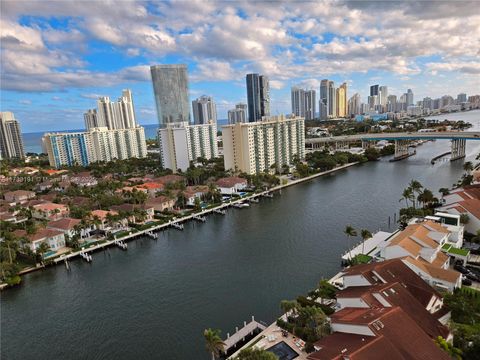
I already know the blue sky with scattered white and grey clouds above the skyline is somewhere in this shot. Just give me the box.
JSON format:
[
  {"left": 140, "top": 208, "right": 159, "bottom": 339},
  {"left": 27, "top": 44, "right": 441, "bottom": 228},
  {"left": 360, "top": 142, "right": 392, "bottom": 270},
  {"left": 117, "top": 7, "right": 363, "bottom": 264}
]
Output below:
[{"left": 0, "top": 0, "right": 480, "bottom": 132}]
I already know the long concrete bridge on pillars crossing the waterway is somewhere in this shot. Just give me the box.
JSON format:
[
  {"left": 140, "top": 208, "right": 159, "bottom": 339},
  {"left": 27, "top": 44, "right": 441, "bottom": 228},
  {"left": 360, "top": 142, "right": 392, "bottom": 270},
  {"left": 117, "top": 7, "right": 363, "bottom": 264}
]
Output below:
[{"left": 305, "top": 131, "right": 480, "bottom": 161}]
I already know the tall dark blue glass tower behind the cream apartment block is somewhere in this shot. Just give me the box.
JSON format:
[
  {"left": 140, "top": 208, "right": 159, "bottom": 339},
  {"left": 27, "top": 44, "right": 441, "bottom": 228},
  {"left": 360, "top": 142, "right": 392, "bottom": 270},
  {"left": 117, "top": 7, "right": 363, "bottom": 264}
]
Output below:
[{"left": 246, "top": 74, "right": 270, "bottom": 122}]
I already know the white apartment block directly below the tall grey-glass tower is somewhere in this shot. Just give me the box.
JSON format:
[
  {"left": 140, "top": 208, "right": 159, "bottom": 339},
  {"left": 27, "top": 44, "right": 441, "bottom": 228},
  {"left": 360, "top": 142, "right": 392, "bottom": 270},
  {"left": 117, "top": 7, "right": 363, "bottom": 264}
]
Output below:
[{"left": 158, "top": 121, "right": 218, "bottom": 172}]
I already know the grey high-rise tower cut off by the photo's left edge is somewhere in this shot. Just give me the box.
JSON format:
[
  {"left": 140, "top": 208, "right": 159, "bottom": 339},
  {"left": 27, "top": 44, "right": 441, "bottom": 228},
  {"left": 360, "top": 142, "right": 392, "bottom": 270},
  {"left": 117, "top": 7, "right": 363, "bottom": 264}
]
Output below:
[{"left": 0, "top": 111, "right": 25, "bottom": 159}]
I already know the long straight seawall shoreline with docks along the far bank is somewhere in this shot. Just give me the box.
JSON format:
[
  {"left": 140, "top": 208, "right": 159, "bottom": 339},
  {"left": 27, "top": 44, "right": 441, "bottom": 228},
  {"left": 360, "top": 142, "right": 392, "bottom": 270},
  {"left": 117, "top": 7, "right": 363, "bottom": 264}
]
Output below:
[{"left": 0, "top": 161, "right": 360, "bottom": 291}]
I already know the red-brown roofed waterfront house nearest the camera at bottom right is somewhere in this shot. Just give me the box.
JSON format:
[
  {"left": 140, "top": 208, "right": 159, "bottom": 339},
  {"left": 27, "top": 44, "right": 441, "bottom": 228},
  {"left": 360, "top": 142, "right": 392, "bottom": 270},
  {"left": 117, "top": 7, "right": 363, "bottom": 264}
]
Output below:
[{"left": 308, "top": 306, "right": 450, "bottom": 360}]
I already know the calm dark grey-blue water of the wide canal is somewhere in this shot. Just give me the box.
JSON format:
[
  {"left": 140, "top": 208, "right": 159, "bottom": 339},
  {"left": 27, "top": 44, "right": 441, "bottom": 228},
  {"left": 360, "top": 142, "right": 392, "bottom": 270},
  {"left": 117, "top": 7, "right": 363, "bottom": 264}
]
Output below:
[{"left": 1, "top": 112, "right": 480, "bottom": 360}]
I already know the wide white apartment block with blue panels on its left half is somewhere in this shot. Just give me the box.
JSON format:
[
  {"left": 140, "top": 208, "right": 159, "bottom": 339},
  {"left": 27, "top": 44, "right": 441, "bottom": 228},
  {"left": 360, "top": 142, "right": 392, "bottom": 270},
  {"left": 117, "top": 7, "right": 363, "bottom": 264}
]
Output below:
[{"left": 42, "top": 126, "right": 147, "bottom": 168}]
